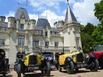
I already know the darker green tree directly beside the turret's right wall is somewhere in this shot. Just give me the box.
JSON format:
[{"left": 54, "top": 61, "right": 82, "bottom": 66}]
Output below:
[{"left": 80, "top": 23, "right": 96, "bottom": 53}]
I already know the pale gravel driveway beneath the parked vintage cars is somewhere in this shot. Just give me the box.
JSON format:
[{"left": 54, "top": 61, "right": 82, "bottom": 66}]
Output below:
[{"left": 2, "top": 69, "right": 103, "bottom": 77}]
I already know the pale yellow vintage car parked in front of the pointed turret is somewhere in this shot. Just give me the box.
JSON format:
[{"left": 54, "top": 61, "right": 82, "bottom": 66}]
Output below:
[{"left": 58, "top": 50, "right": 99, "bottom": 74}]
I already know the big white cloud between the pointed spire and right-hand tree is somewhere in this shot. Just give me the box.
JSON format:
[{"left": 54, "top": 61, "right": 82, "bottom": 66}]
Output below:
[{"left": 73, "top": 0, "right": 100, "bottom": 24}]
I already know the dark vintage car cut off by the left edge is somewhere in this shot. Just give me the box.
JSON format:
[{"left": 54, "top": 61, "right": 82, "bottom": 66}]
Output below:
[{"left": 0, "top": 49, "right": 9, "bottom": 76}]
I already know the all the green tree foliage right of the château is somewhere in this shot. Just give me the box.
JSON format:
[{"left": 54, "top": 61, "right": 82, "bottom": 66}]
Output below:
[{"left": 80, "top": 0, "right": 103, "bottom": 52}]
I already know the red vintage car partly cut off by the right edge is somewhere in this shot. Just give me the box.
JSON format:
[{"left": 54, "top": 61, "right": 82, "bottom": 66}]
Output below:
[{"left": 90, "top": 45, "right": 103, "bottom": 69}]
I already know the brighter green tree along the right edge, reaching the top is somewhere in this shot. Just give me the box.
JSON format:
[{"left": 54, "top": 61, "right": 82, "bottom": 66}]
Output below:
[{"left": 92, "top": 0, "right": 103, "bottom": 44}]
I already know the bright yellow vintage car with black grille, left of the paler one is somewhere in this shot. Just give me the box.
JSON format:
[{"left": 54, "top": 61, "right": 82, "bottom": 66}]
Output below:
[{"left": 14, "top": 53, "right": 50, "bottom": 77}]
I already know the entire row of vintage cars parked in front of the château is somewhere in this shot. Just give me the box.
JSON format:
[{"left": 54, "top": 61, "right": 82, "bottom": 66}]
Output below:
[{"left": 0, "top": 45, "right": 103, "bottom": 77}]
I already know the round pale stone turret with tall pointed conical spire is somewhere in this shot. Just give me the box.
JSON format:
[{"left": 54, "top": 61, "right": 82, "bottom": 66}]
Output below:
[{"left": 58, "top": 0, "right": 82, "bottom": 51}]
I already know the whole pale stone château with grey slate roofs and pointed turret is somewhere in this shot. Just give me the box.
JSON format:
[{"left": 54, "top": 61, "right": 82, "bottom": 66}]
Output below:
[{"left": 0, "top": 0, "right": 82, "bottom": 67}]
